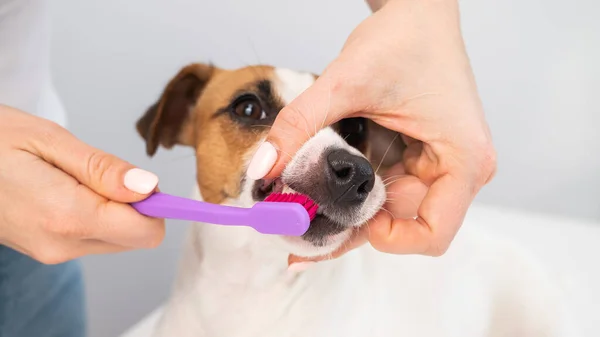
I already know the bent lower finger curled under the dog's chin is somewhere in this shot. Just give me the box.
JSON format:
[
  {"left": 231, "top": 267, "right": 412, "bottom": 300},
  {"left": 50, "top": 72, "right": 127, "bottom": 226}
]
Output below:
[{"left": 369, "top": 175, "right": 473, "bottom": 256}]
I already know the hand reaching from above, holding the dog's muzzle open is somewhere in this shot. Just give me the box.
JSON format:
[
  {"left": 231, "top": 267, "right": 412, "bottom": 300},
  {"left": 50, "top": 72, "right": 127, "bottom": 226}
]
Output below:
[{"left": 248, "top": 0, "right": 496, "bottom": 262}]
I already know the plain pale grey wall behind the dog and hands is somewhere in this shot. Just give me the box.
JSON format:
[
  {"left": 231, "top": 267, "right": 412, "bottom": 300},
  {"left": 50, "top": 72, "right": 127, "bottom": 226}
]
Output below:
[{"left": 52, "top": 0, "right": 600, "bottom": 337}]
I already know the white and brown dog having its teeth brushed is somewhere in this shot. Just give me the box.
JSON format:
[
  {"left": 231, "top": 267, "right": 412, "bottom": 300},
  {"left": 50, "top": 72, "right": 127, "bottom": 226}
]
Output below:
[{"left": 136, "top": 63, "right": 572, "bottom": 337}]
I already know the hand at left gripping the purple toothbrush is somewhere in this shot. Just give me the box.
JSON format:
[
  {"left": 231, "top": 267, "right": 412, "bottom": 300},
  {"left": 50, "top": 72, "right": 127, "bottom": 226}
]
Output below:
[{"left": 0, "top": 106, "right": 165, "bottom": 264}]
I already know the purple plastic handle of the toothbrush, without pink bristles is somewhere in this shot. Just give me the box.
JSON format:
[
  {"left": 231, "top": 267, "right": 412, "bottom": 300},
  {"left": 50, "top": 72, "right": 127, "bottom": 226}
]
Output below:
[{"left": 131, "top": 192, "right": 310, "bottom": 236}]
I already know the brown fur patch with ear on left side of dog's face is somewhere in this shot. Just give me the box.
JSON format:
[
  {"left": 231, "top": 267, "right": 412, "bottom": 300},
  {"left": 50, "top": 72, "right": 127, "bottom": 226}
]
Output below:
[{"left": 137, "top": 64, "right": 274, "bottom": 203}]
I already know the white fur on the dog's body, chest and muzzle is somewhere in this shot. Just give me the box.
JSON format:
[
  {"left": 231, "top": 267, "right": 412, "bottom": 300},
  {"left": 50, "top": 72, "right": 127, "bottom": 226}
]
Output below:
[{"left": 148, "top": 70, "right": 572, "bottom": 337}]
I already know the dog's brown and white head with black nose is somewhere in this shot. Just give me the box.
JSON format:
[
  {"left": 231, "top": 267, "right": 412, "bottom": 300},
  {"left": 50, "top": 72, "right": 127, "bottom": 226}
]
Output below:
[{"left": 137, "top": 64, "right": 394, "bottom": 256}]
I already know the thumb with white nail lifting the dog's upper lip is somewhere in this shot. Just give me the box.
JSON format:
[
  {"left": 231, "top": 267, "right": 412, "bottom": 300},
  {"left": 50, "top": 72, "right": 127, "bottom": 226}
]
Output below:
[{"left": 246, "top": 74, "right": 348, "bottom": 180}]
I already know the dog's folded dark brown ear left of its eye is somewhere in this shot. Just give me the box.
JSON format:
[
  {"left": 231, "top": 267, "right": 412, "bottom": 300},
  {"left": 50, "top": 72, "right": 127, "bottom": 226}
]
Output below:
[{"left": 136, "top": 63, "right": 215, "bottom": 156}]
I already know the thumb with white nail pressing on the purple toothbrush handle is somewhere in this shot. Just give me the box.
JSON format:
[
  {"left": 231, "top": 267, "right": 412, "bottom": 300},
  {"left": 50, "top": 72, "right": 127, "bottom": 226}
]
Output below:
[{"left": 32, "top": 126, "right": 158, "bottom": 203}]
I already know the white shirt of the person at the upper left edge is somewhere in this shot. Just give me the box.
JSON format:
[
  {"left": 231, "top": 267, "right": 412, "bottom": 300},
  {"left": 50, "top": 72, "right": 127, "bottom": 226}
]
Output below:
[{"left": 0, "top": 0, "right": 66, "bottom": 126}]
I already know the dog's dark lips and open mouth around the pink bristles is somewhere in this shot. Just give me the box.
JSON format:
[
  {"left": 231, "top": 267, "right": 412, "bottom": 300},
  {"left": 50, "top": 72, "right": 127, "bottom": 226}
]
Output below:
[{"left": 252, "top": 178, "right": 348, "bottom": 247}]
